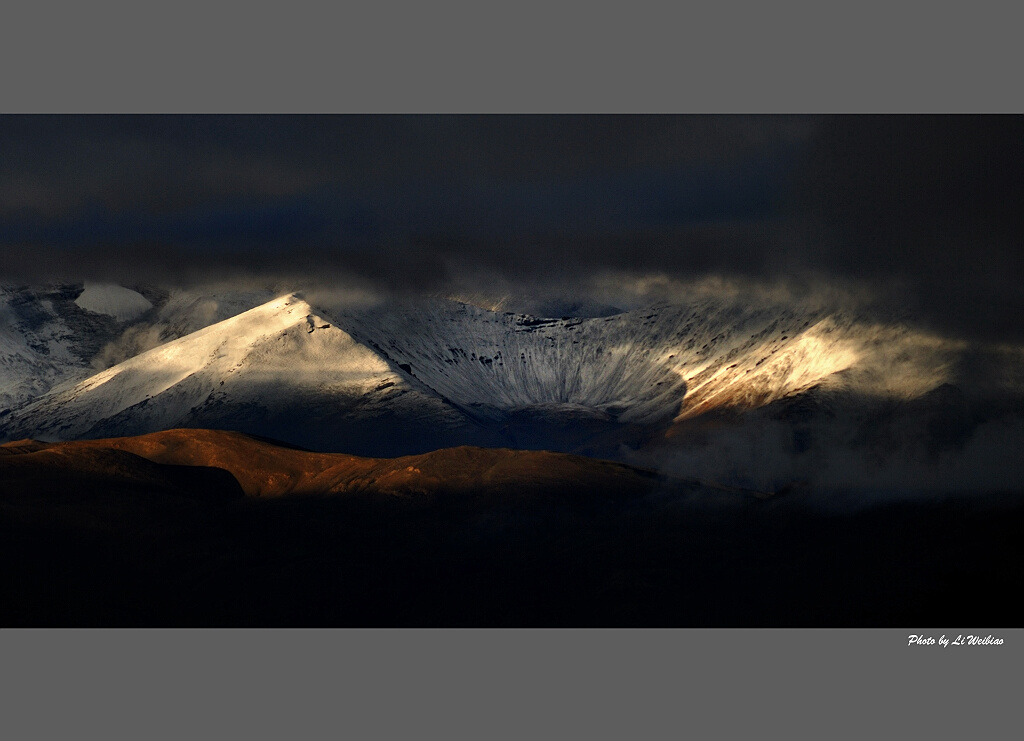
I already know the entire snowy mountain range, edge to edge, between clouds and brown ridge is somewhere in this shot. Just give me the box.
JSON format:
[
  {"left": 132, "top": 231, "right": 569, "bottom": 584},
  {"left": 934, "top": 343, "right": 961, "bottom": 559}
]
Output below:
[{"left": 0, "top": 278, "right": 1024, "bottom": 490}]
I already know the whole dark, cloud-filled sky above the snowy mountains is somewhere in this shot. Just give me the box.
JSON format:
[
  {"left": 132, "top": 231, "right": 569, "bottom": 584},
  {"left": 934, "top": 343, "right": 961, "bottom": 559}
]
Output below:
[{"left": 0, "top": 116, "right": 1024, "bottom": 337}]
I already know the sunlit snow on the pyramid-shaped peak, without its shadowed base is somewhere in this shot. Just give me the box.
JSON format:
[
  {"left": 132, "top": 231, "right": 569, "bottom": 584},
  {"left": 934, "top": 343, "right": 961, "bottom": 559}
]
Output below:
[{"left": 6, "top": 295, "right": 466, "bottom": 446}]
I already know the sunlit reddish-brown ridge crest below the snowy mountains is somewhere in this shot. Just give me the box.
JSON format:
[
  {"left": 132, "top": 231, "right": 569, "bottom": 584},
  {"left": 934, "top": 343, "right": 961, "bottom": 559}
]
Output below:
[{"left": 0, "top": 429, "right": 658, "bottom": 497}]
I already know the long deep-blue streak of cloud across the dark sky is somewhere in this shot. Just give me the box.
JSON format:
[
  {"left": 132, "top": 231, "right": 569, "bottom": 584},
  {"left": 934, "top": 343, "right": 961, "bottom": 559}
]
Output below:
[{"left": 0, "top": 149, "right": 786, "bottom": 248}]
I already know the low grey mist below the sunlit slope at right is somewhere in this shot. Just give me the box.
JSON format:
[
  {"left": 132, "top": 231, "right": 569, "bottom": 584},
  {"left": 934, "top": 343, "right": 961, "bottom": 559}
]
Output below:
[{"left": 624, "top": 412, "right": 1024, "bottom": 505}]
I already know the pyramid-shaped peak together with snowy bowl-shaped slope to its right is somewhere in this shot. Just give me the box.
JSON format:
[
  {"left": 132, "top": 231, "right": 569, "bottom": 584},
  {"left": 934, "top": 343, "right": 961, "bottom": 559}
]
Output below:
[{"left": 0, "top": 284, "right": 1003, "bottom": 468}]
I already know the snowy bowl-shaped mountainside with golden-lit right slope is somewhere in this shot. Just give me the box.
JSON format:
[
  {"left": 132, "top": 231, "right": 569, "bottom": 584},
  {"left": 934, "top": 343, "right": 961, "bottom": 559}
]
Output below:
[{"left": 329, "top": 294, "right": 872, "bottom": 424}]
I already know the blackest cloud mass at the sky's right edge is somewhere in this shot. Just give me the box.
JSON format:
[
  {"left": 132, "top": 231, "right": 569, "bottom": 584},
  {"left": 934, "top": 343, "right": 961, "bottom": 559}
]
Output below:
[{"left": 787, "top": 116, "right": 1024, "bottom": 339}]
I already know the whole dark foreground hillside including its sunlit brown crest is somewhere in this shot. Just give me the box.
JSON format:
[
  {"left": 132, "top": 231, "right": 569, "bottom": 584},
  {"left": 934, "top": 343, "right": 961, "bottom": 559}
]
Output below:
[{"left": 0, "top": 430, "right": 1024, "bottom": 627}]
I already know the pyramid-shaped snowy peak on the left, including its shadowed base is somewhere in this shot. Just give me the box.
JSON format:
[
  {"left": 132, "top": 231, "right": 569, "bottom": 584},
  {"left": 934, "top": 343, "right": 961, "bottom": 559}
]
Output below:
[{"left": 5, "top": 295, "right": 463, "bottom": 454}]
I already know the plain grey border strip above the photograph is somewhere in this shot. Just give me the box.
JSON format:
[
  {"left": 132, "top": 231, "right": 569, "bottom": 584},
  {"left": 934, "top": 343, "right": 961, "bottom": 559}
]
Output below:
[{"left": 0, "top": 0, "right": 1024, "bottom": 113}]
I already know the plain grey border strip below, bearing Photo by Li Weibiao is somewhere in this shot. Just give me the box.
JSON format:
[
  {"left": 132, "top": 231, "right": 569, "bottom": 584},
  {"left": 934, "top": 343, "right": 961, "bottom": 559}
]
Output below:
[{"left": 0, "top": 628, "right": 1024, "bottom": 739}]
